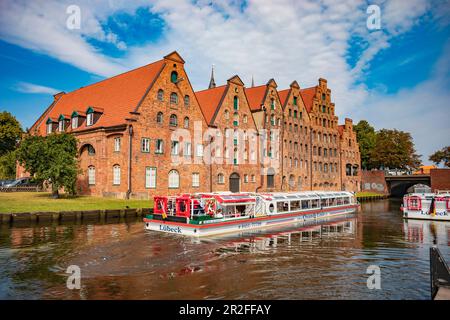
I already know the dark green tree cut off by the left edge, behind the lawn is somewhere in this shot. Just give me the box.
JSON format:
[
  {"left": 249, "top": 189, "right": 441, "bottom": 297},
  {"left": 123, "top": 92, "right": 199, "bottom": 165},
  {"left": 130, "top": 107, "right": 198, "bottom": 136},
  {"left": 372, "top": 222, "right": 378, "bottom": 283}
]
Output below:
[{"left": 0, "top": 111, "right": 22, "bottom": 156}]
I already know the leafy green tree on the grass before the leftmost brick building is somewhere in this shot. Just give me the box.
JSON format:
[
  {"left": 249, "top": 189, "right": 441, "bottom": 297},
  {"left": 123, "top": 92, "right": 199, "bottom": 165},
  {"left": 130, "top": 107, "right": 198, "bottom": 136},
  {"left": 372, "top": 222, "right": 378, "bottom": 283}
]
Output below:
[{"left": 17, "top": 133, "right": 79, "bottom": 198}]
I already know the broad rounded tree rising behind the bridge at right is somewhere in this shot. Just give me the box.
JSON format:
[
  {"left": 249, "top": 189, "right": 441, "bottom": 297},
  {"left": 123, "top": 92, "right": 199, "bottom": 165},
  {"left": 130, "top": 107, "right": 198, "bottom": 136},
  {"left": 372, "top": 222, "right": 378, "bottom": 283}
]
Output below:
[{"left": 370, "top": 129, "right": 421, "bottom": 169}]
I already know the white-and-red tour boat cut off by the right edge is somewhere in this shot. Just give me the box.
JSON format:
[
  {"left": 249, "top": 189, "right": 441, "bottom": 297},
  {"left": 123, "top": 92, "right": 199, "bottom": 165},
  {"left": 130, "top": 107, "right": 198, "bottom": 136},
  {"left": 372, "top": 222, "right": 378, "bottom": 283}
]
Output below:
[{"left": 400, "top": 187, "right": 450, "bottom": 221}]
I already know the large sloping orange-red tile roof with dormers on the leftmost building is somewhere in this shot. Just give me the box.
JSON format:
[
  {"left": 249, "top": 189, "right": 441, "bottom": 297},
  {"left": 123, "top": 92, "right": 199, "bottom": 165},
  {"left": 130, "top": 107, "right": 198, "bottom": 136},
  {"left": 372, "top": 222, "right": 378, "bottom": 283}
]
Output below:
[{"left": 35, "top": 60, "right": 164, "bottom": 133}]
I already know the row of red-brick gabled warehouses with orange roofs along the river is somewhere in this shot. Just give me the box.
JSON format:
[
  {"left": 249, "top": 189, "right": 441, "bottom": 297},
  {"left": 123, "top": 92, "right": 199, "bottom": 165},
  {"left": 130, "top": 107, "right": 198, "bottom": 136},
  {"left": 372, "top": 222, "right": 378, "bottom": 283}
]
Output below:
[{"left": 22, "top": 52, "right": 360, "bottom": 198}]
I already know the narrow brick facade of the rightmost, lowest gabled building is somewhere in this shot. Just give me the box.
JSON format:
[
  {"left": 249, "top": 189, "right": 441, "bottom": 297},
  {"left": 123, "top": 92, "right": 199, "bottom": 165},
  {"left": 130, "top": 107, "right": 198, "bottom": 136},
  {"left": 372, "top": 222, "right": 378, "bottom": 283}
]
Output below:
[{"left": 340, "top": 118, "right": 361, "bottom": 192}]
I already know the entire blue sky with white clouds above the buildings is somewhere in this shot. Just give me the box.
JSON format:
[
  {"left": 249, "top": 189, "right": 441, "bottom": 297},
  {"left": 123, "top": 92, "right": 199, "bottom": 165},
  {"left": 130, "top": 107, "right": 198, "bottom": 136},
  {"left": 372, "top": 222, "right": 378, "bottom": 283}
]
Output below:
[{"left": 0, "top": 0, "right": 450, "bottom": 163}]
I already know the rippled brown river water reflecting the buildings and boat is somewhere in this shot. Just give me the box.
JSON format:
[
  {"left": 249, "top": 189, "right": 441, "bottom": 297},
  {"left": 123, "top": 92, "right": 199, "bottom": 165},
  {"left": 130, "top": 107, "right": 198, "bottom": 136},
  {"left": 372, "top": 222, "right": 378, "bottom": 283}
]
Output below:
[{"left": 0, "top": 199, "right": 450, "bottom": 299}]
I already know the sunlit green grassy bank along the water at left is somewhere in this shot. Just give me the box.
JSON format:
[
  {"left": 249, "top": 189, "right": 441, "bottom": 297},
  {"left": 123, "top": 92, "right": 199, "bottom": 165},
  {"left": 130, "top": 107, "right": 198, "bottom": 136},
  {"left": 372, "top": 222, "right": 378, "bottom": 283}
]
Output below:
[{"left": 0, "top": 192, "right": 153, "bottom": 213}]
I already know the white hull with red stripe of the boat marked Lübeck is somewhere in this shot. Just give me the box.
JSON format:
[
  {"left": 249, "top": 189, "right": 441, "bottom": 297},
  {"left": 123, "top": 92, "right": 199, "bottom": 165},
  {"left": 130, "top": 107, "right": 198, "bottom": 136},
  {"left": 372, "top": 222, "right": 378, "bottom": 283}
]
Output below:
[{"left": 144, "top": 205, "right": 358, "bottom": 237}]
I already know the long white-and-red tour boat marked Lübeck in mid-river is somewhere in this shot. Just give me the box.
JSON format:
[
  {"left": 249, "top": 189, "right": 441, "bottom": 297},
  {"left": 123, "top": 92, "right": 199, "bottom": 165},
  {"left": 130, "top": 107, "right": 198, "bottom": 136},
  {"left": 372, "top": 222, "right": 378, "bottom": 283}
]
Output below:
[{"left": 144, "top": 191, "right": 359, "bottom": 237}]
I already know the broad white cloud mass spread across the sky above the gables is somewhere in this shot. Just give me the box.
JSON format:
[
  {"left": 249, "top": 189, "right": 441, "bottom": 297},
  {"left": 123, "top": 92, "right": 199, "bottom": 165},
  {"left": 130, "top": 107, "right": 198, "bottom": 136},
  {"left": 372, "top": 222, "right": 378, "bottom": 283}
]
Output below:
[{"left": 0, "top": 0, "right": 449, "bottom": 162}]
